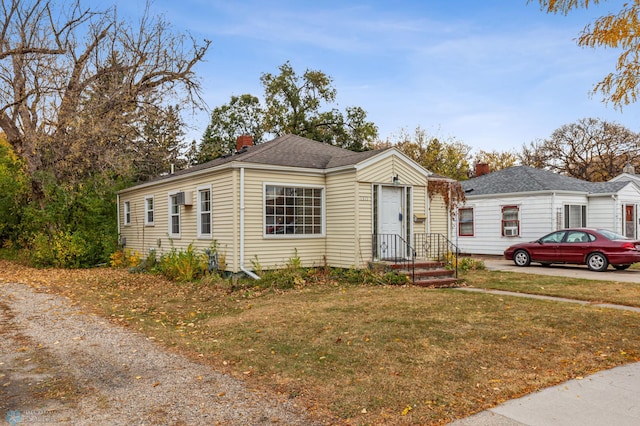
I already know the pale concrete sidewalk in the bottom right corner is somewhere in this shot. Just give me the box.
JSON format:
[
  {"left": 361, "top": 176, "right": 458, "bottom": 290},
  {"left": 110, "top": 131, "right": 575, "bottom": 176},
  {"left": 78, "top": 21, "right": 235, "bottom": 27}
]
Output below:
[{"left": 450, "top": 363, "right": 640, "bottom": 426}]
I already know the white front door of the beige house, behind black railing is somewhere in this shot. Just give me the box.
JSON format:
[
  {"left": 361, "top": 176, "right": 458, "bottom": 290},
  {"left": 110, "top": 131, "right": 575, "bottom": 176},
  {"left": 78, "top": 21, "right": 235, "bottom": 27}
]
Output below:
[{"left": 378, "top": 186, "right": 405, "bottom": 259}]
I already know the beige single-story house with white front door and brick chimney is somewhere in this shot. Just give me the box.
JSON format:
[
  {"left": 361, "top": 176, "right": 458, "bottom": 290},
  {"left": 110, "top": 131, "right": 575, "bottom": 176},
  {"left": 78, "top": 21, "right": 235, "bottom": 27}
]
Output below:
[{"left": 118, "top": 135, "right": 450, "bottom": 275}]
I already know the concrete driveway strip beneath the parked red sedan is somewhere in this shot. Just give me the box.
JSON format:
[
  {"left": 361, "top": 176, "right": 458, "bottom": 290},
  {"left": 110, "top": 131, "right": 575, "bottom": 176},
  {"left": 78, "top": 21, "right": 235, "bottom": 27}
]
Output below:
[{"left": 479, "top": 256, "right": 640, "bottom": 283}]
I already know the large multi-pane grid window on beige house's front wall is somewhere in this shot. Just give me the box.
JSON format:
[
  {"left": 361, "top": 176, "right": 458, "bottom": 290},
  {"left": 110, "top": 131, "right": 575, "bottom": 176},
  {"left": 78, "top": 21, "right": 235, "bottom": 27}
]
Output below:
[{"left": 264, "top": 185, "right": 323, "bottom": 235}]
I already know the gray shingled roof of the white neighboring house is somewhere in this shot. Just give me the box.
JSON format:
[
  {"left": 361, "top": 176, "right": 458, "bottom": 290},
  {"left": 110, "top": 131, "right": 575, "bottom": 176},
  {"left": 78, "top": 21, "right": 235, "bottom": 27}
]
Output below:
[{"left": 461, "top": 166, "right": 629, "bottom": 196}]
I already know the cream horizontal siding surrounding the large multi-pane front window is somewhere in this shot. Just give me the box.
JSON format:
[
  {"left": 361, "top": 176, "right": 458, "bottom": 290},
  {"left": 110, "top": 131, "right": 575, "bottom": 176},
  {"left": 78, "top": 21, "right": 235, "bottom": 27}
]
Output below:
[{"left": 244, "top": 169, "right": 326, "bottom": 269}]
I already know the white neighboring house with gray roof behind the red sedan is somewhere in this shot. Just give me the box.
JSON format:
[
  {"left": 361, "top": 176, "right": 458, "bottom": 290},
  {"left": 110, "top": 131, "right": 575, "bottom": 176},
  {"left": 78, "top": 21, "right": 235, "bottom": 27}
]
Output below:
[{"left": 454, "top": 166, "right": 640, "bottom": 255}]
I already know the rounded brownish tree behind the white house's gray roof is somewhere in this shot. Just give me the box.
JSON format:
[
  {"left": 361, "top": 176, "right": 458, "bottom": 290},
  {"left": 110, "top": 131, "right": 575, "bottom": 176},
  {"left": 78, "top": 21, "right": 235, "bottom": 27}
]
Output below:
[{"left": 519, "top": 118, "right": 640, "bottom": 182}]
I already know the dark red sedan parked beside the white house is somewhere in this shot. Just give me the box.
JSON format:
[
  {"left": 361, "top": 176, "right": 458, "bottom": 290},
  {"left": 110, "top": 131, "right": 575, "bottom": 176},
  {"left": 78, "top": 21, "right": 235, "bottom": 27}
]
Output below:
[{"left": 504, "top": 228, "right": 640, "bottom": 272}]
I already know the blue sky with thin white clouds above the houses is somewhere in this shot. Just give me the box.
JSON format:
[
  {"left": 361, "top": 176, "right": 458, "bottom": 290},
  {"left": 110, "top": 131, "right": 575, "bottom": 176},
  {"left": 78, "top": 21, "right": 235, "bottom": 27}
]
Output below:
[{"left": 109, "top": 0, "right": 640, "bottom": 152}]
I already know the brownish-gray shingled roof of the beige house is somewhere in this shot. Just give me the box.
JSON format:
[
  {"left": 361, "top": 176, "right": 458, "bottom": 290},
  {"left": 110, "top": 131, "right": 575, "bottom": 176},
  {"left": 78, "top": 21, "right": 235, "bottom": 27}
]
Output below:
[{"left": 144, "top": 135, "right": 389, "bottom": 185}]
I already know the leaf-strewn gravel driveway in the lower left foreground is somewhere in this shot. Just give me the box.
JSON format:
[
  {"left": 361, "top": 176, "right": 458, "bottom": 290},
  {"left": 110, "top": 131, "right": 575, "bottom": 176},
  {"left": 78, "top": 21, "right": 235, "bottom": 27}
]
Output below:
[{"left": 0, "top": 284, "right": 312, "bottom": 425}]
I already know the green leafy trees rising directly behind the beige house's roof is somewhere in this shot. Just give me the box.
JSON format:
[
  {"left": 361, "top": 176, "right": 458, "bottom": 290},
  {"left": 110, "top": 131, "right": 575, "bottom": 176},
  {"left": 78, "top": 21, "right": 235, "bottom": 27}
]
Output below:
[{"left": 198, "top": 62, "right": 378, "bottom": 162}]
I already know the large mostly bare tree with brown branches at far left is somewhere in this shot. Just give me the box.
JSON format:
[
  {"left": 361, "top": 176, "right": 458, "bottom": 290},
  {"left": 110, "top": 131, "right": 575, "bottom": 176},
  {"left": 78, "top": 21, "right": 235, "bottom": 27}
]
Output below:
[{"left": 0, "top": 0, "right": 209, "bottom": 202}]
